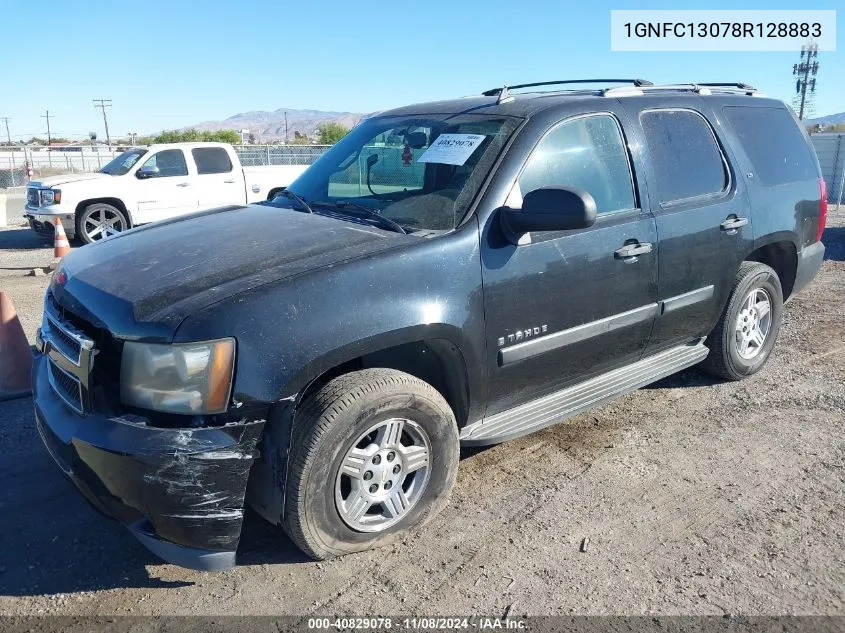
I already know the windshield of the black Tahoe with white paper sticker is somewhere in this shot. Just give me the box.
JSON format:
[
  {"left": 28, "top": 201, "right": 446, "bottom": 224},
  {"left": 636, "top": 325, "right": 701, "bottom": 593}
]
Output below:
[{"left": 280, "top": 114, "right": 519, "bottom": 232}]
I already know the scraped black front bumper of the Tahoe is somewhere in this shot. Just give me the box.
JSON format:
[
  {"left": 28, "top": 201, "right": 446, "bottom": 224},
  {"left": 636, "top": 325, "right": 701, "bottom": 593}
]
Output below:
[{"left": 32, "top": 354, "right": 265, "bottom": 571}]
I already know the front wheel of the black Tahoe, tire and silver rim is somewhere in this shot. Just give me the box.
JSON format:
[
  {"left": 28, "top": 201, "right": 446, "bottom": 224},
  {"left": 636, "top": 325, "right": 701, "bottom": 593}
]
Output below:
[{"left": 284, "top": 369, "right": 459, "bottom": 559}]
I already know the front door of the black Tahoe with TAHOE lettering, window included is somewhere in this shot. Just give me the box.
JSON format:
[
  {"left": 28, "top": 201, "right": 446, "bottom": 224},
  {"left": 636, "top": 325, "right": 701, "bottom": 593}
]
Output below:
[{"left": 482, "top": 106, "right": 657, "bottom": 416}]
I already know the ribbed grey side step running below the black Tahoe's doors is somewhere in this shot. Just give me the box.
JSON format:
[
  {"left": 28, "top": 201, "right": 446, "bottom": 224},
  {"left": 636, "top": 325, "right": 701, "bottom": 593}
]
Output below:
[{"left": 460, "top": 339, "right": 710, "bottom": 446}]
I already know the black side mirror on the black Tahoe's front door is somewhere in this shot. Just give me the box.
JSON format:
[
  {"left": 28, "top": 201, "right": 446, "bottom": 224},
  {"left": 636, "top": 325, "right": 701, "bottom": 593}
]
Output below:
[{"left": 499, "top": 187, "right": 596, "bottom": 243}]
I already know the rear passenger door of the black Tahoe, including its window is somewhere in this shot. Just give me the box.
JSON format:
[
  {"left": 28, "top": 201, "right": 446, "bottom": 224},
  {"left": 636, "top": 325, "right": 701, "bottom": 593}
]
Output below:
[{"left": 628, "top": 97, "right": 753, "bottom": 354}]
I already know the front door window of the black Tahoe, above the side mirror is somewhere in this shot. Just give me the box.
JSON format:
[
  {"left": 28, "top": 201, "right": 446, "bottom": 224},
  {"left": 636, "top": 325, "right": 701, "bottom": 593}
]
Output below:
[{"left": 519, "top": 115, "right": 635, "bottom": 213}]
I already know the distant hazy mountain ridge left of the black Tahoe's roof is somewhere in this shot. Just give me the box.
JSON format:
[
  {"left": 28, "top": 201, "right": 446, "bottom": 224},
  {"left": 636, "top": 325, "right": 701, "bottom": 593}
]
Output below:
[{"left": 189, "top": 108, "right": 363, "bottom": 141}]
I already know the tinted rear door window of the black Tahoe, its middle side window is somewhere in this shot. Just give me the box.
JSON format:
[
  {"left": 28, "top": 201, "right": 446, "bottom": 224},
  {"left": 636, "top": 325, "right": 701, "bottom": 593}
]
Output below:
[{"left": 641, "top": 110, "right": 728, "bottom": 202}]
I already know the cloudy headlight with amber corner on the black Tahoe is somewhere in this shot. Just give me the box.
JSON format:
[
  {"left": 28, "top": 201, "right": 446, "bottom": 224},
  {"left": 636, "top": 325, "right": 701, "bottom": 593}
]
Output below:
[{"left": 120, "top": 338, "right": 235, "bottom": 414}]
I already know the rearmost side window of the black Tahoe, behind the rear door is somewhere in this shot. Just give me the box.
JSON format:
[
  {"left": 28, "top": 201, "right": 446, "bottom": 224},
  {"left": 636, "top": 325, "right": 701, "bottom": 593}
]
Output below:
[{"left": 725, "top": 106, "right": 818, "bottom": 187}]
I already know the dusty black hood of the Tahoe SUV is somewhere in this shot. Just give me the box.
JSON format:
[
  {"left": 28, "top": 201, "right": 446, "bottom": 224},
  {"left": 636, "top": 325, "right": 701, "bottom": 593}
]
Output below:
[{"left": 51, "top": 205, "right": 408, "bottom": 341}]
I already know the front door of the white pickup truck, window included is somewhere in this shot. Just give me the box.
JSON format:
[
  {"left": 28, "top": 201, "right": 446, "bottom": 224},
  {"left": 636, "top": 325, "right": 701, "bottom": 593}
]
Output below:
[{"left": 135, "top": 149, "right": 197, "bottom": 224}]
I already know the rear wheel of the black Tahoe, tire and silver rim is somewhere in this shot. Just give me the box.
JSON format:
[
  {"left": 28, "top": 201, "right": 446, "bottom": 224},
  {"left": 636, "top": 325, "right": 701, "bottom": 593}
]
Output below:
[{"left": 702, "top": 262, "right": 783, "bottom": 380}]
